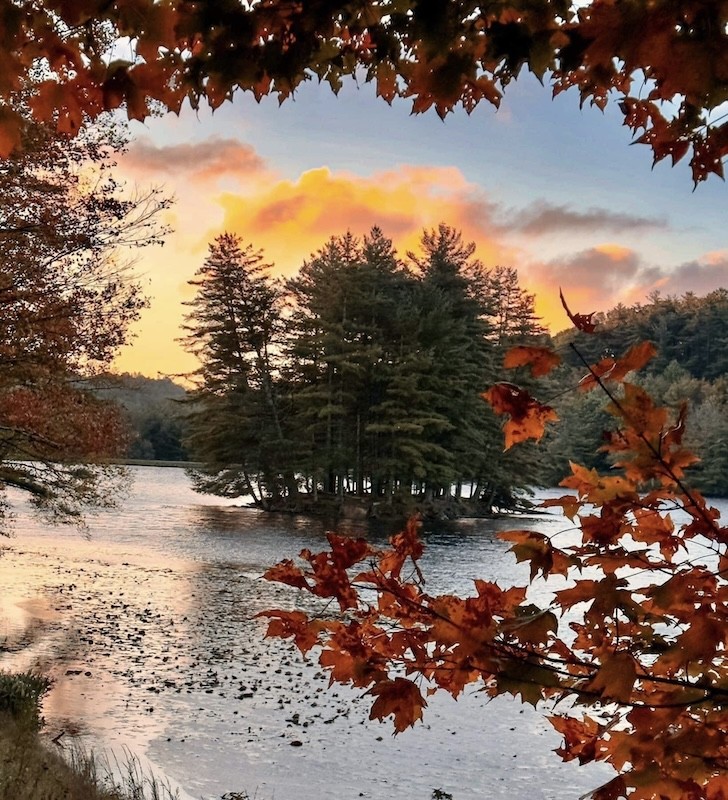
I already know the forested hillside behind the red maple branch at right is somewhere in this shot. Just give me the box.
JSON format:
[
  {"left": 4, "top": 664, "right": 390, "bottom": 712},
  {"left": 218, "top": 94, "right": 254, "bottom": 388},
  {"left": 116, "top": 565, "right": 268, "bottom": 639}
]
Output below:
[{"left": 540, "top": 289, "right": 728, "bottom": 496}]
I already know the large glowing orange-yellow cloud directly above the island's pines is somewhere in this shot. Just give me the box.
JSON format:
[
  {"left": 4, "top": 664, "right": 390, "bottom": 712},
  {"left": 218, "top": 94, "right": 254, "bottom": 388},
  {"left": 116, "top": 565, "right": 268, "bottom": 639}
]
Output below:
[{"left": 213, "top": 166, "right": 517, "bottom": 274}]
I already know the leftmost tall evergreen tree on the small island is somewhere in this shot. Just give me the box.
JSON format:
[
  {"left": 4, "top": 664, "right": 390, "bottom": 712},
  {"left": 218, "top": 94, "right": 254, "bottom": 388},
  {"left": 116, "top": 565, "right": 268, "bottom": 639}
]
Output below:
[{"left": 184, "top": 233, "right": 297, "bottom": 504}]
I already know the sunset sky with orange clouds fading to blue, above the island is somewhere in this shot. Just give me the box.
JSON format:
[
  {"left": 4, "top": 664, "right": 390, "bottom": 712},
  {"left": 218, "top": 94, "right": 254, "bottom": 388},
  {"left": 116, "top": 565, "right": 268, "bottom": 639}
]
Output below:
[{"left": 115, "top": 75, "right": 728, "bottom": 376}]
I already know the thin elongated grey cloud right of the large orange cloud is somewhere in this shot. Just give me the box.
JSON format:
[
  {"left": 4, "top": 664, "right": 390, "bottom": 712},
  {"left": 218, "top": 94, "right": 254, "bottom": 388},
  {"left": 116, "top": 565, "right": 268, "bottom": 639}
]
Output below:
[{"left": 499, "top": 201, "right": 667, "bottom": 236}]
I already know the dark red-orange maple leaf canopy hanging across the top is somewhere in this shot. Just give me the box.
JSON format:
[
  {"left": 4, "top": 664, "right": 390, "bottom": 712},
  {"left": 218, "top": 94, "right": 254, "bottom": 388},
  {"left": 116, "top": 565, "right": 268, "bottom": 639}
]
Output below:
[{"left": 0, "top": 0, "right": 728, "bottom": 182}]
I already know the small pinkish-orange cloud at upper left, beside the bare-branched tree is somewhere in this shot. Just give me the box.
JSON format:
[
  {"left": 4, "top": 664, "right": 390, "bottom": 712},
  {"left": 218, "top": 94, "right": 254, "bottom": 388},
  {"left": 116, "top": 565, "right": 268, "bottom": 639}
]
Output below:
[{"left": 122, "top": 137, "right": 269, "bottom": 182}]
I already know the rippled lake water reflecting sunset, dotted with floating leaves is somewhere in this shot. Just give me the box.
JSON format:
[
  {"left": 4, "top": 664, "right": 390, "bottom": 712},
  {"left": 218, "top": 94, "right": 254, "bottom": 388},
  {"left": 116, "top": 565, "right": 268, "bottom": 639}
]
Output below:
[{"left": 0, "top": 467, "right": 612, "bottom": 800}]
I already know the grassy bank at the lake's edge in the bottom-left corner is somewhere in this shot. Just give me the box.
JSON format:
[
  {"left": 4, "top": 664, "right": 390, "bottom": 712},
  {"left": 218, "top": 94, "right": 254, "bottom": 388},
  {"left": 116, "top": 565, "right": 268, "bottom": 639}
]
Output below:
[{"left": 0, "top": 673, "right": 176, "bottom": 800}]
